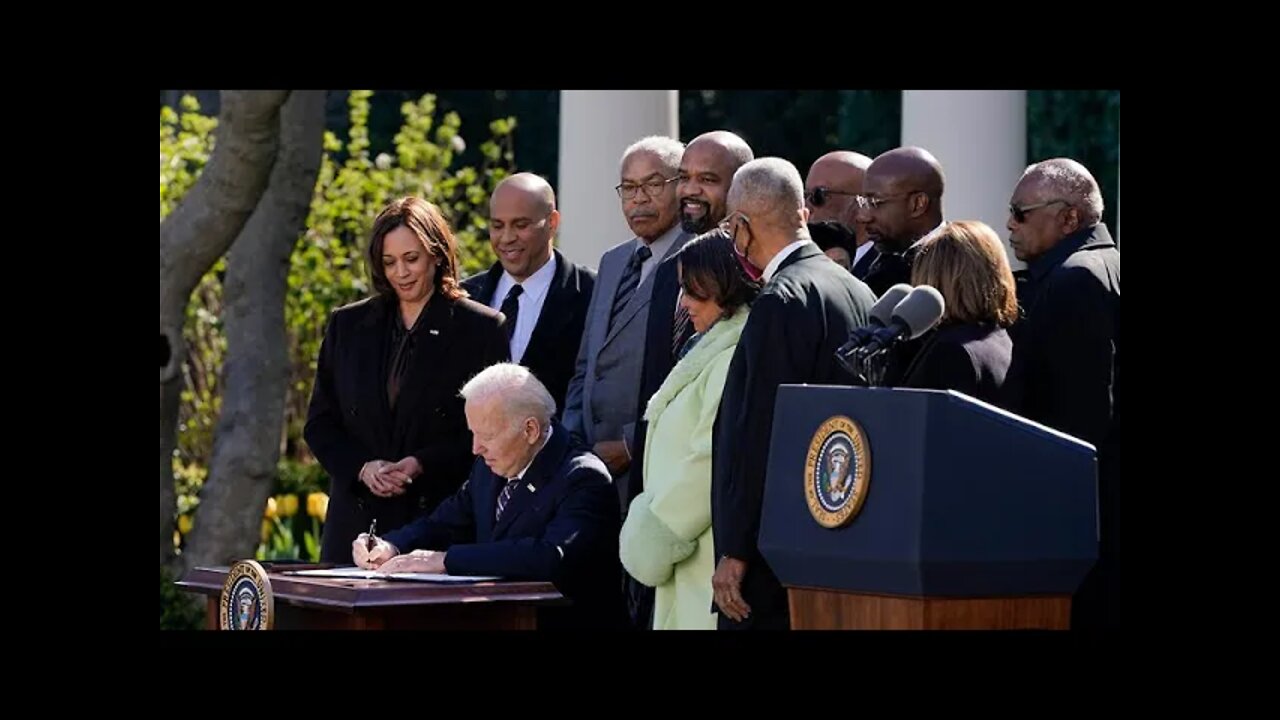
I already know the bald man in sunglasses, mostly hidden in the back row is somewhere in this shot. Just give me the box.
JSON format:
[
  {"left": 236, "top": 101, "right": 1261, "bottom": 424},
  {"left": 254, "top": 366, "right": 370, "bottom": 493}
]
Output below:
[{"left": 804, "top": 150, "right": 876, "bottom": 278}]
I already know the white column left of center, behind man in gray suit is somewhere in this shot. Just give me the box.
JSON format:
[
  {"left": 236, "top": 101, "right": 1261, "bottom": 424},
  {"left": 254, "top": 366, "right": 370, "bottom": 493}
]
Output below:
[{"left": 556, "top": 90, "right": 680, "bottom": 268}]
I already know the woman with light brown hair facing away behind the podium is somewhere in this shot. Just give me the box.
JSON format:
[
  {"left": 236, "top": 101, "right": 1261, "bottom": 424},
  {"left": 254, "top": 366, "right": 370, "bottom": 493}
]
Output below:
[{"left": 900, "top": 220, "right": 1018, "bottom": 405}]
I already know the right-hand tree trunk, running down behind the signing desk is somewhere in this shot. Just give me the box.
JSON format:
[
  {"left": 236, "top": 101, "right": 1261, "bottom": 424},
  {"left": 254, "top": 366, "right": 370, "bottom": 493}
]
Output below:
[{"left": 182, "top": 90, "right": 325, "bottom": 569}]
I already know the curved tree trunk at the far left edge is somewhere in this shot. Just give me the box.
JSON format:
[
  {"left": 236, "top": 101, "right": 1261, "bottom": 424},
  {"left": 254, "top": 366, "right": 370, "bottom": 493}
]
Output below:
[{"left": 160, "top": 90, "right": 289, "bottom": 565}]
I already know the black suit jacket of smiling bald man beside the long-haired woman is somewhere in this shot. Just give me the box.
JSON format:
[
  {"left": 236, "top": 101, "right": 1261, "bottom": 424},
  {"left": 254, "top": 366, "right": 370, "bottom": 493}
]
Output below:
[{"left": 462, "top": 250, "right": 595, "bottom": 414}]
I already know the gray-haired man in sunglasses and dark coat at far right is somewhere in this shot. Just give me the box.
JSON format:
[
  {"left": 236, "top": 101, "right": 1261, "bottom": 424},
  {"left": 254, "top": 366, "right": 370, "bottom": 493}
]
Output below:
[{"left": 1005, "top": 158, "right": 1120, "bottom": 629}]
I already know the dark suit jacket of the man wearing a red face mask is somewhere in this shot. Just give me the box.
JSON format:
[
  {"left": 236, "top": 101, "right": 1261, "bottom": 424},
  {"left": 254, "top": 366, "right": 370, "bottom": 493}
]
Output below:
[{"left": 712, "top": 242, "right": 876, "bottom": 626}]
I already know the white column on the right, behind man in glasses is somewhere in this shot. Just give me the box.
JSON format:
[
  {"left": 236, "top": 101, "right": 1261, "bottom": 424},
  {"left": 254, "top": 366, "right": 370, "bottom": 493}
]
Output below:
[{"left": 902, "top": 90, "right": 1027, "bottom": 270}]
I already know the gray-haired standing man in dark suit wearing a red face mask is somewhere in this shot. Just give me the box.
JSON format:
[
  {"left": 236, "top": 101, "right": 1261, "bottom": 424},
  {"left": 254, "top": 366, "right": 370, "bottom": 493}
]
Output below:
[{"left": 712, "top": 158, "right": 876, "bottom": 629}]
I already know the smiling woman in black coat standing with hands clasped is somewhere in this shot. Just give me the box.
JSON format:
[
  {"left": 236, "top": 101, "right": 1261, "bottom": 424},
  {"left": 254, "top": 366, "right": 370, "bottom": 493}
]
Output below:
[{"left": 305, "top": 197, "right": 509, "bottom": 564}]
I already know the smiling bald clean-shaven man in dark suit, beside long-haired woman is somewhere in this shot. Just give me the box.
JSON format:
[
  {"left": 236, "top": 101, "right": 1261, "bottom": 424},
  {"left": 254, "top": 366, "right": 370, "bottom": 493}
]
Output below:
[{"left": 462, "top": 173, "right": 595, "bottom": 407}]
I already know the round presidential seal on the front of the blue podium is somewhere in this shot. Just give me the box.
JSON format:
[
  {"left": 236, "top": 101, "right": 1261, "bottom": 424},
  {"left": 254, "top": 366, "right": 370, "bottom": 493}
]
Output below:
[{"left": 804, "top": 415, "right": 872, "bottom": 528}]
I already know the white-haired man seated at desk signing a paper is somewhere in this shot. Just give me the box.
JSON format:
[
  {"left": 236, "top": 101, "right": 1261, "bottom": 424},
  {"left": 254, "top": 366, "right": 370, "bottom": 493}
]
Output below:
[{"left": 352, "top": 363, "right": 623, "bottom": 628}]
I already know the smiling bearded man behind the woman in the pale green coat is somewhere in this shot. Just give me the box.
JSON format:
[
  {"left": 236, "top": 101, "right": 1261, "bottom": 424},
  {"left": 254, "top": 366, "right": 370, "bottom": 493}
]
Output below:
[{"left": 623, "top": 131, "right": 754, "bottom": 628}]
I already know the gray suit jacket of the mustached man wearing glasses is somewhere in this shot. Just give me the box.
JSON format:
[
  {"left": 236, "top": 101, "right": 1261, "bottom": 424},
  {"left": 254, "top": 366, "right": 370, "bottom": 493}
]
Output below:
[{"left": 563, "top": 232, "right": 692, "bottom": 497}]
